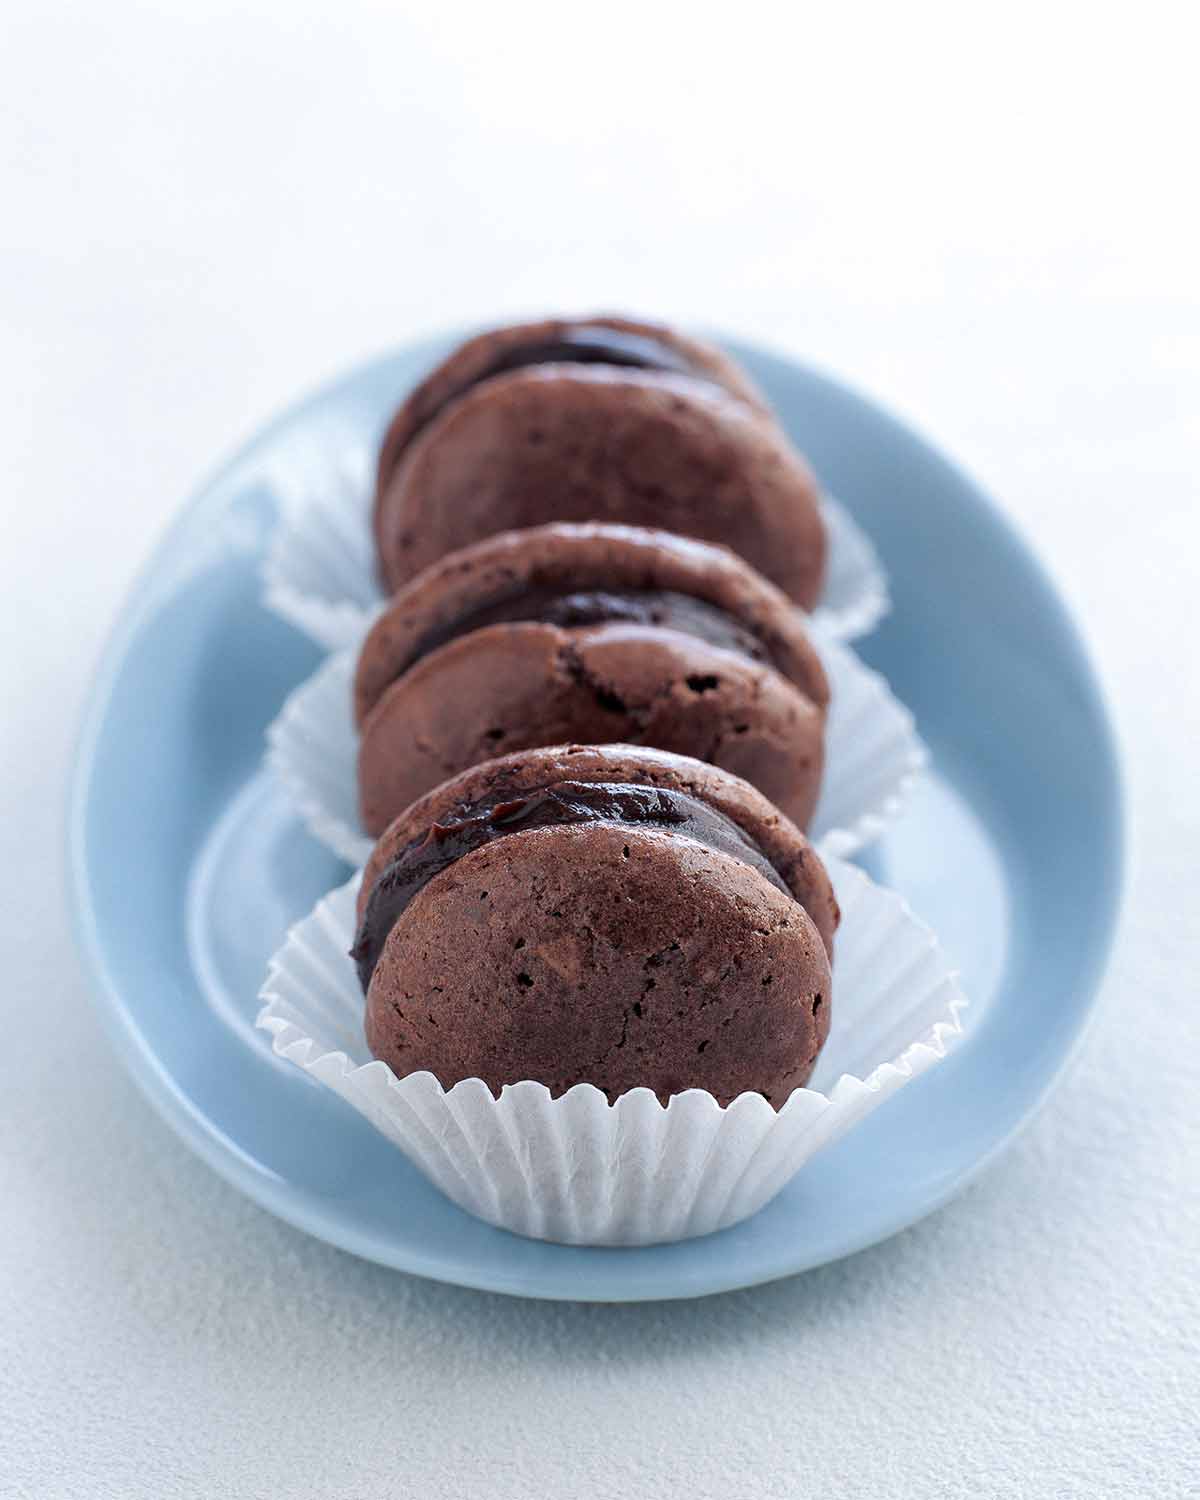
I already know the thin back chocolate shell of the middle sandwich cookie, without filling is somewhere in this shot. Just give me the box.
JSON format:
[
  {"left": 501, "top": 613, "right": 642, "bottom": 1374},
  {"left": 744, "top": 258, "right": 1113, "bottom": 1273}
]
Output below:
[{"left": 354, "top": 522, "right": 830, "bottom": 726}]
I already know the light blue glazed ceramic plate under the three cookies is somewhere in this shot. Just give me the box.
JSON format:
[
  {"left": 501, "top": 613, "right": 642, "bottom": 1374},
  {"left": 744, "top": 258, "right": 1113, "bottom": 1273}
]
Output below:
[{"left": 71, "top": 344, "right": 1122, "bottom": 1301}]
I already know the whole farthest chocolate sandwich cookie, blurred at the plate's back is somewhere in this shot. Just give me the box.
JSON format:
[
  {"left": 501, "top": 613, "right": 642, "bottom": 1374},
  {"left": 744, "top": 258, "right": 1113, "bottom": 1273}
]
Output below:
[{"left": 375, "top": 318, "right": 827, "bottom": 609}]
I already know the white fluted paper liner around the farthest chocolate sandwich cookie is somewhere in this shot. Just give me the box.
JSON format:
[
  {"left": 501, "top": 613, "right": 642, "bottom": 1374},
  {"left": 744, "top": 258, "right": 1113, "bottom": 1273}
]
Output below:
[{"left": 263, "top": 429, "right": 888, "bottom": 651}]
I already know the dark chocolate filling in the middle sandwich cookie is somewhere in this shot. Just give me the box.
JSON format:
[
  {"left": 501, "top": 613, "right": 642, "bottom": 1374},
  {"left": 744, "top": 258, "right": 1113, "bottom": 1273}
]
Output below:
[{"left": 408, "top": 588, "right": 768, "bottom": 666}]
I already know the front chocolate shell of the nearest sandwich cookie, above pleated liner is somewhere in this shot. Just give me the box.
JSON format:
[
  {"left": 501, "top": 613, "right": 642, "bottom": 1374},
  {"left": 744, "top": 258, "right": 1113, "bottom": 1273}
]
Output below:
[{"left": 366, "top": 824, "right": 830, "bottom": 1106}]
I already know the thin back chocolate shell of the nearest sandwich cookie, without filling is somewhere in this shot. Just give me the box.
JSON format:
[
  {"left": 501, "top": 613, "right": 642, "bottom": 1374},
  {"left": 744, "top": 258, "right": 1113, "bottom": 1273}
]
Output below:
[{"left": 359, "top": 744, "right": 839, "bottom": 954}]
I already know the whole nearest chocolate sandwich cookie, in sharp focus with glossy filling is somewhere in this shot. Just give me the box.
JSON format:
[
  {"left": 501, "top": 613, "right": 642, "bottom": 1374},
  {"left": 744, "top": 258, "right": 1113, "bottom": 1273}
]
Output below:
[{"left": 353, "top": 746, "right": 839, "bottom": 1109}]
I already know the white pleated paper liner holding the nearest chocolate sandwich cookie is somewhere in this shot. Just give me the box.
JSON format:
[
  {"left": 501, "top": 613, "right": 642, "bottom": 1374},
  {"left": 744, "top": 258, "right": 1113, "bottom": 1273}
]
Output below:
[{"left": 258, "top": 860, "right": 966, "bottom": 1245}]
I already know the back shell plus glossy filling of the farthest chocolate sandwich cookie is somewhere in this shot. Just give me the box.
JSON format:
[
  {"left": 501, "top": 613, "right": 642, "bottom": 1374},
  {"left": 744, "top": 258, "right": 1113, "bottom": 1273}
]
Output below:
[{"left": 378, "top": 314, "right": 767, "bottom": 510}]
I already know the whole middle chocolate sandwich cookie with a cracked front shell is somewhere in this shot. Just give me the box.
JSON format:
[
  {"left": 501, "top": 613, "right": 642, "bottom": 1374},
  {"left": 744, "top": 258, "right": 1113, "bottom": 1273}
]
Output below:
[{"left": 354, "top": 524, "right": 830, "bottom": 836}]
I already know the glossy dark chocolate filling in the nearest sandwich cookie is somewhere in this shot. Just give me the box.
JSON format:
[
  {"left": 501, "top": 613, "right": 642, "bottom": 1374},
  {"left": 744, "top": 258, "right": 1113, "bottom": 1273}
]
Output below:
[{"left": 350, "top": 782, "right": 792, "bottom": 993}]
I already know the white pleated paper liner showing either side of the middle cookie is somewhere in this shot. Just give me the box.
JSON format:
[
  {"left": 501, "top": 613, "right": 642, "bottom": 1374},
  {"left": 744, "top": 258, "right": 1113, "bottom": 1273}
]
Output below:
[{"left": 267, "top": 632, "right": 927, "bottom": 864}]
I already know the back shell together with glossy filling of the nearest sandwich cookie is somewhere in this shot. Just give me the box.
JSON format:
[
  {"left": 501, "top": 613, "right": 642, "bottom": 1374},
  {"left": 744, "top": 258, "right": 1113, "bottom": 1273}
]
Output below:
[{"left": 354, "top": 746, "right": 839, "bottom": 966}]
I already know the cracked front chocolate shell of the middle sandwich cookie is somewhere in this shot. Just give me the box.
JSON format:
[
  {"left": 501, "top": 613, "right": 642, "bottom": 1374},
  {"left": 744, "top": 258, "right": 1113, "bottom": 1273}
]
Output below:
[{"left": 359, "top": 624, "right": 825, "bottom": 834}]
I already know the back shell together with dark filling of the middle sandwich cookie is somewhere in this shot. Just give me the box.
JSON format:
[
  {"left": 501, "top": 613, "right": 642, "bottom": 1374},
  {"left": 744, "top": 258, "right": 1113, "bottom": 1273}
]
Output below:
[{"left": 354, "top": 524, "right": 830, "bottom": 725}]
